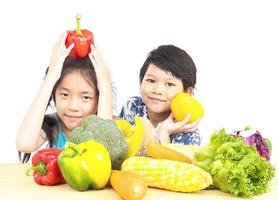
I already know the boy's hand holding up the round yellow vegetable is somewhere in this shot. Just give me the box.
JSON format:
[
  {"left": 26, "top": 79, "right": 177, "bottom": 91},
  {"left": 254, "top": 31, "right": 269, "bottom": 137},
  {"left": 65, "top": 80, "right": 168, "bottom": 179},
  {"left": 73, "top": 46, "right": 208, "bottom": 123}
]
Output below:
[{"left": 158, "top": 113, "right": 200, "bottom": 143}]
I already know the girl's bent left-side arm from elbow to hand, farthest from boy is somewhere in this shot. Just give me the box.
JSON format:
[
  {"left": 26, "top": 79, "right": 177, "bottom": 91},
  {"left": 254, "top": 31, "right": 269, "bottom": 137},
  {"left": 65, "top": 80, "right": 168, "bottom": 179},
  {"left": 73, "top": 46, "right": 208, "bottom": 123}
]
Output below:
[{"left": 16, "top": 33, "right": 73, "bottom": 153}]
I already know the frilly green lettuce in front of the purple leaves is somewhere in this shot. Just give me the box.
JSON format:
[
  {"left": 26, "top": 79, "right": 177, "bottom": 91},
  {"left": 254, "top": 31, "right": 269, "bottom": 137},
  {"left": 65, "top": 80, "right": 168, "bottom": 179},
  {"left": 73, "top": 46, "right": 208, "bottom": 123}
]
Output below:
[{"left": 193, "top": 129, "right": 274, "bottom": 197}]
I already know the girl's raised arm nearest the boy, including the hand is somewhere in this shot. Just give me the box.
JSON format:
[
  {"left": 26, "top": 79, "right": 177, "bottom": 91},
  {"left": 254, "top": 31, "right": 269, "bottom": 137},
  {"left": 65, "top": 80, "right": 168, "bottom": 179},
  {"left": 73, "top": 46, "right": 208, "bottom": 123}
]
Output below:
[{"left": 89, "top": 45, "right": 112, "bottom": 119}]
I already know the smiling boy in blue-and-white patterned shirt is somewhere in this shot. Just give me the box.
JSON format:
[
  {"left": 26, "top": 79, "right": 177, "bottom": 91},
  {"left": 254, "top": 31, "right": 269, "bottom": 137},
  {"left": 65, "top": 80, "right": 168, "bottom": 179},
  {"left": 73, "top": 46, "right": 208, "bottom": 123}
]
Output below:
[{"left": 120, "top": 45, "right": 201, "bottom": 145}]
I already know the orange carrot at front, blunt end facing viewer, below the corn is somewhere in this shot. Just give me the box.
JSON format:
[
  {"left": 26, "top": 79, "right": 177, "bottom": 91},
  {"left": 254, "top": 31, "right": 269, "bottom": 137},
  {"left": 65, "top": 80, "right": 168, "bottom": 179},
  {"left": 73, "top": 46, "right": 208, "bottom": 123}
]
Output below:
[{"left": 110, "top": 170, "right": 148, "bottom": 200}]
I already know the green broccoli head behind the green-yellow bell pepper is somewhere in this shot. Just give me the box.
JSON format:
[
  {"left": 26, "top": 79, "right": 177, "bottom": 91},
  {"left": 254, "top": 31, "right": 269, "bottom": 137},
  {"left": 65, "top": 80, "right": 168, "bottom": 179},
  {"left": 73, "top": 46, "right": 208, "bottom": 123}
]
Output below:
[{"left": 69, "top": 115, "right": 128, "bottom": 169}]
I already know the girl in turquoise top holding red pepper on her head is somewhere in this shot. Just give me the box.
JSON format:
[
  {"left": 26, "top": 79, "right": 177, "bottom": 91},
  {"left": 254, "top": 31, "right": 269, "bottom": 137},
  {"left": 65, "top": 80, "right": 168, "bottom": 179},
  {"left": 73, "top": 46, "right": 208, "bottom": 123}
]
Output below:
[{"left": 16, "top": 33, "right": 112, "bottom": 162}]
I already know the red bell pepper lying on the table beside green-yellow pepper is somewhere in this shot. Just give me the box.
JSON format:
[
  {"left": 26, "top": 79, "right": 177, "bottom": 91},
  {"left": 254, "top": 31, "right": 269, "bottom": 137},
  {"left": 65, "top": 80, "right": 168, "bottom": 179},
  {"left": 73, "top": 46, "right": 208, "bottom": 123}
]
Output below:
[{"left": 27, "top": 148, "right": 65, "bottom": 185}]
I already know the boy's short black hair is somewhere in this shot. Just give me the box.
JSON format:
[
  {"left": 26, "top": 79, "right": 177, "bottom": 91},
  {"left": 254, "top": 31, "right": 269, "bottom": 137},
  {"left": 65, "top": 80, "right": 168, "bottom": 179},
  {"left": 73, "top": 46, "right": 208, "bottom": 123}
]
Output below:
[{"left": 139, "top": 45, "right": 197, "bottom": 90}]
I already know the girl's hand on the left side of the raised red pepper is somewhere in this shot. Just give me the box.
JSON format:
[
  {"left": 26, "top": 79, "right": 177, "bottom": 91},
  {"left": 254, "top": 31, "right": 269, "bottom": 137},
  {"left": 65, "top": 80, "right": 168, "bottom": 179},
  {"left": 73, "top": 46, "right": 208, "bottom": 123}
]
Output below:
[{"left": 47, "top": 32, "right": 74, "bottom": 80}]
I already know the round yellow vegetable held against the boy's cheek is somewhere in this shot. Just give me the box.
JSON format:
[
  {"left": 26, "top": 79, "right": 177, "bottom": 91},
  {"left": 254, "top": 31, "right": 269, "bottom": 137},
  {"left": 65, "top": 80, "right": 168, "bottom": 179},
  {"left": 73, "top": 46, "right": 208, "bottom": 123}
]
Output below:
[{"left": 171, "top": 92, "right": 205, "bottom": 122}]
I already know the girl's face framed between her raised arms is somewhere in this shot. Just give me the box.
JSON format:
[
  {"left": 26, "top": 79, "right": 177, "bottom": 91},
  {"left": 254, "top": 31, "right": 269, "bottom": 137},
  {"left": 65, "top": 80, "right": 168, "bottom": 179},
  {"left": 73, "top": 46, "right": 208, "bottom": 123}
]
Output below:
[{"left": 55, "top": 71, "right": 98, "bottom": 134}]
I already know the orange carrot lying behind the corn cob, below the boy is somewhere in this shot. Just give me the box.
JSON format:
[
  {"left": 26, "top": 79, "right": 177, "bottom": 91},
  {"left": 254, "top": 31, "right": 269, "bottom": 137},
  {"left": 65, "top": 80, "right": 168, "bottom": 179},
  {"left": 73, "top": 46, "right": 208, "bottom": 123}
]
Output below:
[{"left": 147, "top": 143, "right": 192, "bottom": 163}]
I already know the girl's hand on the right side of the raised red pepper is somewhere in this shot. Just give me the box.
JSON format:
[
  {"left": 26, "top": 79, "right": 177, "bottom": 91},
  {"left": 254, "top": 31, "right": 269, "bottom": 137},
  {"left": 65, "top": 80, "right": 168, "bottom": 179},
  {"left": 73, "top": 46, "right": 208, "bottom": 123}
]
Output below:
[{"left": 89, "top": 45, "right": 112, "bottom": 92}]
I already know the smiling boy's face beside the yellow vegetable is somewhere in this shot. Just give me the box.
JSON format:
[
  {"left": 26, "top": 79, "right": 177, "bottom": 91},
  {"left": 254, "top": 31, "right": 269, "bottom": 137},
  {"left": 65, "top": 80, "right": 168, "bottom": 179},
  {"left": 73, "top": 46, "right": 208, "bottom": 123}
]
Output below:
[{"left": 140, "top": 64, "right": 184, "bottom": 114}]
